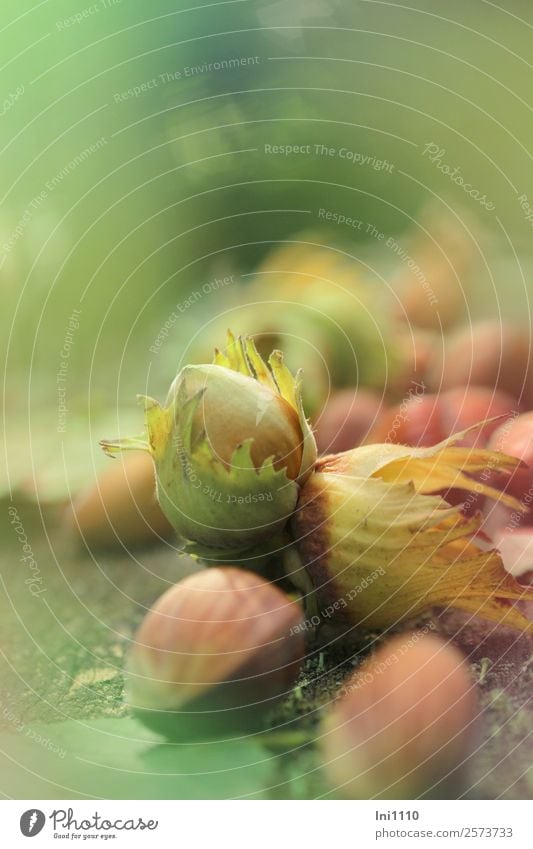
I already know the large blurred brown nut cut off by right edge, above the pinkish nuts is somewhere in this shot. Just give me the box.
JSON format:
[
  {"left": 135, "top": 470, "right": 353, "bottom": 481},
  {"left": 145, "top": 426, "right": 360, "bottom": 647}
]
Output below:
[{"left": 428, "top": 321, "right": 533, "bottom": 409}]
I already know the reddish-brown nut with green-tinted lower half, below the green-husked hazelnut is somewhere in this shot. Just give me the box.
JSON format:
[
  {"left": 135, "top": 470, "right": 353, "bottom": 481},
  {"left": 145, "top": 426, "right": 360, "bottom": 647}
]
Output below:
[{"left": 127, "top": 567, "right": 305, "bottom": 740}]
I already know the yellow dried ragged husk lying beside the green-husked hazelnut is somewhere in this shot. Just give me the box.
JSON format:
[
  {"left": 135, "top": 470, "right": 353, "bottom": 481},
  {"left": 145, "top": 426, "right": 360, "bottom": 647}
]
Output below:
[{"left": 291, "top": 424, "right": 533, "bottom": 632}]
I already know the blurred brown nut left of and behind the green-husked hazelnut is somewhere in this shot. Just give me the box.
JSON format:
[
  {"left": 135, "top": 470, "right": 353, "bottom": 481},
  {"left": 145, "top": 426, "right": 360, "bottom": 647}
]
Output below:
[{"left": 69, "top": 452, "right": 173, "bottom": 548}]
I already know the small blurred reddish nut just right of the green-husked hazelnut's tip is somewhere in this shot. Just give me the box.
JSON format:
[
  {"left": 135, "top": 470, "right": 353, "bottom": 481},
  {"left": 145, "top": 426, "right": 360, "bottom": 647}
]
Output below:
[{"left": 315, "top": 389, "right": 382, "bottom": 454}]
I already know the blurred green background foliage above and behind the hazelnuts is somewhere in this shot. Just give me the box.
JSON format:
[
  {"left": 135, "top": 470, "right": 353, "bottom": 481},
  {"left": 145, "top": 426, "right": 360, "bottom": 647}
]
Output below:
[{"left": 0, "top": 0, "right": 533, "bottom": 498}]
